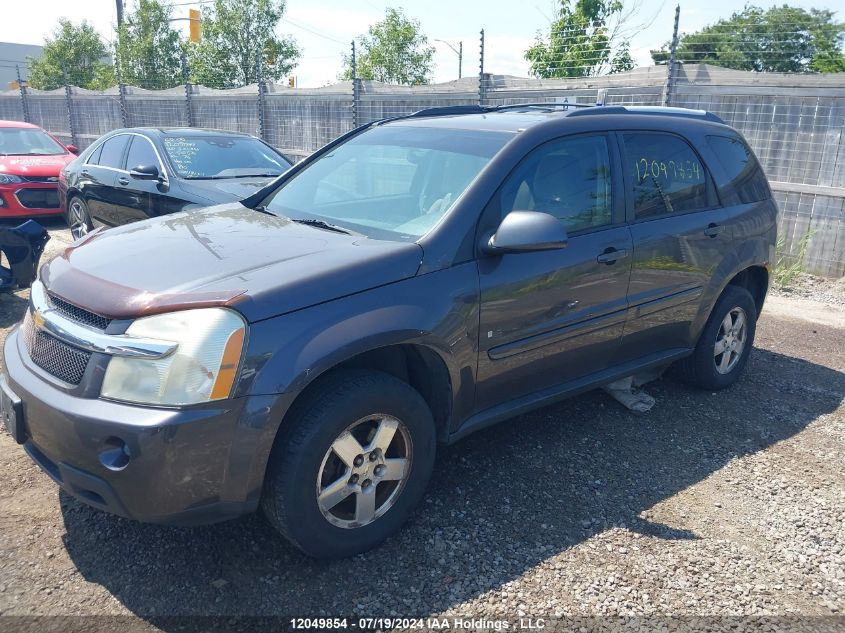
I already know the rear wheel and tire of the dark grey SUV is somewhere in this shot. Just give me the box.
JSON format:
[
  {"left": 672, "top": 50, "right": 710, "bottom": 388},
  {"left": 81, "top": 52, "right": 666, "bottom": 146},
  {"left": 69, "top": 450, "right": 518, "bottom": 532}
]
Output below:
[{"left": 677, "top": 286, "right": 757, "bottom": 391}]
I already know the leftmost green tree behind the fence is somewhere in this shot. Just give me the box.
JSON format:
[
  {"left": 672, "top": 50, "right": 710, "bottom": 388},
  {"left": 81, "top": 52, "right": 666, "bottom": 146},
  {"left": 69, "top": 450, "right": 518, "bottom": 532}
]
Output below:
[{"left": 29, "top": 18, "right": 115, "bottom": 90}]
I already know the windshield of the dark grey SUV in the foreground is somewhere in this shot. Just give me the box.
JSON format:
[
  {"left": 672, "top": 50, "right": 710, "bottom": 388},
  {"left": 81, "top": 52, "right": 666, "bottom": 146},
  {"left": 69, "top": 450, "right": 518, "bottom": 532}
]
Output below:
[{"left": 265, "top": 125, "right": 513, "bottom": 241}]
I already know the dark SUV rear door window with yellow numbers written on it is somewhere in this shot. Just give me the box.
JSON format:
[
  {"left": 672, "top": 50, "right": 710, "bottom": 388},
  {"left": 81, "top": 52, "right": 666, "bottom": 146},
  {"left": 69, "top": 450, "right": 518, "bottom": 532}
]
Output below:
[{"left": 622, "top": 132, "right": 716, "bottom": 220}]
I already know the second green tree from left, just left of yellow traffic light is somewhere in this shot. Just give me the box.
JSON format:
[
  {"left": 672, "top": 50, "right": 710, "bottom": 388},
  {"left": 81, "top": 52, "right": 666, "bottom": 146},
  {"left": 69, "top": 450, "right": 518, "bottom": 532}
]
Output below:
[{"left": 116, "top": 0, "right": 182, "bottom": 89}]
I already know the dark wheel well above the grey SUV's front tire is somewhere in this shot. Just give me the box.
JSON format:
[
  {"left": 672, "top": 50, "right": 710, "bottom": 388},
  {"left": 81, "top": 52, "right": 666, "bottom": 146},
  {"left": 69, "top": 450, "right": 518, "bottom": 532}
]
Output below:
[{"left": 299, "top": 345, "right": 452, "bottom": 440}]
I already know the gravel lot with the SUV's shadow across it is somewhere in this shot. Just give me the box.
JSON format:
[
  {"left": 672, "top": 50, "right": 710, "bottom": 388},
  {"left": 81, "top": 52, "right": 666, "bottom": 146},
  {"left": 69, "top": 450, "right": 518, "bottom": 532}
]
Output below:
[{"left": 0, "top": 225, "right": 845, "bottom": 631}]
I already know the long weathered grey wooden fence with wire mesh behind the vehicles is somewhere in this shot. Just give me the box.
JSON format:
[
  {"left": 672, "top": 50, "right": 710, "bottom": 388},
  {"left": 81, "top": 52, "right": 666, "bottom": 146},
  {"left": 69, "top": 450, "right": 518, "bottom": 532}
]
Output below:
[{"left": 0, "top": 13, "right": 845, "bottom": 276}]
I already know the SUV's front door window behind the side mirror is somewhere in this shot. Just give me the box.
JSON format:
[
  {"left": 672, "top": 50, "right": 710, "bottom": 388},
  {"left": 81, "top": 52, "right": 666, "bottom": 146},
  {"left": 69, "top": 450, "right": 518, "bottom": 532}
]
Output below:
[{"left": 500, "top": 136, "right": 611, "bottom": 233}]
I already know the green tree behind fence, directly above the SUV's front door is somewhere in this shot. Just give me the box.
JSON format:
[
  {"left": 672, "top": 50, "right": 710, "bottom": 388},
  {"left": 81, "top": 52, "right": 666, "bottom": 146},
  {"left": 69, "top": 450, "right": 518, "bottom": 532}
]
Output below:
[{"left": 525, "top": 0, "right": 634, "bottom": 78}]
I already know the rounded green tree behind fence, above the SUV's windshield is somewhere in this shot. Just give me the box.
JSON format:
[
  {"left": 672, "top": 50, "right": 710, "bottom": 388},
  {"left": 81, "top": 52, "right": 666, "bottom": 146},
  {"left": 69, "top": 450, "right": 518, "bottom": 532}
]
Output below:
[{"left": 340, "top": 8, "right": 434, "bottom": 86}]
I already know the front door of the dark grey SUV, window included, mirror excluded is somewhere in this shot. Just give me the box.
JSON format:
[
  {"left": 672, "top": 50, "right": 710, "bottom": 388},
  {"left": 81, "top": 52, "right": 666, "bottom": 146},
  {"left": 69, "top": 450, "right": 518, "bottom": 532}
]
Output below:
[{"left": 476, "top": 134, "right": 632, "bottom": 411}]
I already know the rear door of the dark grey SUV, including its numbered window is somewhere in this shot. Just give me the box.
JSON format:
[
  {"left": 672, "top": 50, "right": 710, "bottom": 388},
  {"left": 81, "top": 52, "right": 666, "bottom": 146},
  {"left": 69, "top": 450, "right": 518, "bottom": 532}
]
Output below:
[{"left": 618, "top": 131, "right": 731, "bottom": 360}]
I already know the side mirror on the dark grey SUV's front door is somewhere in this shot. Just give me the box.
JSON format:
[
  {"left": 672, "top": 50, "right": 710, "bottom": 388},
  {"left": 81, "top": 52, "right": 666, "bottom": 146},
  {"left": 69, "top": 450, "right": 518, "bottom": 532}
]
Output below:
[{"left": 483, "top": 211, "right": 569, "bottom": 254}]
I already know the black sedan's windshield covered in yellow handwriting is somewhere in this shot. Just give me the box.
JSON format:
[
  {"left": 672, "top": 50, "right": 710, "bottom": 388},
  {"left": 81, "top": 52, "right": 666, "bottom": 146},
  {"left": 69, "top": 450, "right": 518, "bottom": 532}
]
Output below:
[{"left": 164, "top": 134, "right": 290, "bottom": 180}]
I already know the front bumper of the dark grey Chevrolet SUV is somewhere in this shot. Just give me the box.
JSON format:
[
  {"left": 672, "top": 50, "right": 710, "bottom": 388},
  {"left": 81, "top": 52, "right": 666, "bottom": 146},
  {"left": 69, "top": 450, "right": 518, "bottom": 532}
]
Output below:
[{"left": 3, "top": 329, "right": 278, "bottom": 525}]
